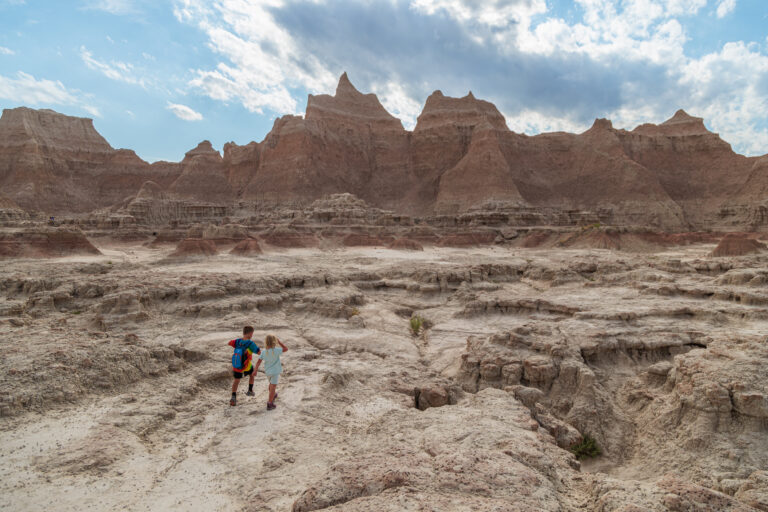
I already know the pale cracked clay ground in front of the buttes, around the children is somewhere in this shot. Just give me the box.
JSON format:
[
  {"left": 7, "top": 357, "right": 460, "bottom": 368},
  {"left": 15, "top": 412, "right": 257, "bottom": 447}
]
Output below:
[{"left": 0, "top": 240, "right": 768, "bottom": 512}]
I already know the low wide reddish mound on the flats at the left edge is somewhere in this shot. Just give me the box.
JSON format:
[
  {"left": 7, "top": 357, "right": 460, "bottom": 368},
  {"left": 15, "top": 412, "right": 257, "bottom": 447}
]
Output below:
[{"left": 0, "top": 227, "right": 101, "bottom": 258}]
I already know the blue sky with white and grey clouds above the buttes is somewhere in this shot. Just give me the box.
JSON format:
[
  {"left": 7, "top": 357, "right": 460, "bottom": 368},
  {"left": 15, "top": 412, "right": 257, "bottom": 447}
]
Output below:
[{"left": 0, "top": 0, "right": 768, "bottom": 161}]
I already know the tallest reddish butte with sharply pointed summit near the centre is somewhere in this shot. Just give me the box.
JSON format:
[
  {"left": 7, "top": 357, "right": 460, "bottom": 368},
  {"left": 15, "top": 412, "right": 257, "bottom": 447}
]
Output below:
[{"left": 242, "top": 74, "right": 417, "bottom": 211}]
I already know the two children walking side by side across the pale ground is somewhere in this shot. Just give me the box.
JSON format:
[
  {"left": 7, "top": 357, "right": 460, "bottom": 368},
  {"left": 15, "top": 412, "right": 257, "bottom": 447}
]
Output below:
[{"left": 229, "top": 325, "right": 288, "bottom": 411}]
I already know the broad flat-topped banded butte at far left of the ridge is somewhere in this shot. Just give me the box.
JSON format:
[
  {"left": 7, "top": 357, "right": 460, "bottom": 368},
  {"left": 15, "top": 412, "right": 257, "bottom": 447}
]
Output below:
[{"left": 0, "top": 107, "right": 179, "bottom": 214}]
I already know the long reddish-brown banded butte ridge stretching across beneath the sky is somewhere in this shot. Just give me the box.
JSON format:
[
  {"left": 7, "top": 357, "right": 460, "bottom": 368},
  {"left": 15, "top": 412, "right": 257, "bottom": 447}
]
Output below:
[{"left": 0, "top": 73, "right": 768, "bottom": 231}]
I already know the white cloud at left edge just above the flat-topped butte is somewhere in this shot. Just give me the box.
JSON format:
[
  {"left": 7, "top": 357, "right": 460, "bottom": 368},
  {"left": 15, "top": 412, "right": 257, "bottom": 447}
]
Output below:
[{"left": 0, "top": 71, "right": 101, "bottom": 117}]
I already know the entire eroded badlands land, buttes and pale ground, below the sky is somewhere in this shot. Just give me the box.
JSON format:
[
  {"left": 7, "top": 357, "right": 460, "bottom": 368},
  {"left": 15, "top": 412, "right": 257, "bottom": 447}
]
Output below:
[{"left": 0, "top": 74, "right": 768, "bottom": 512}]
